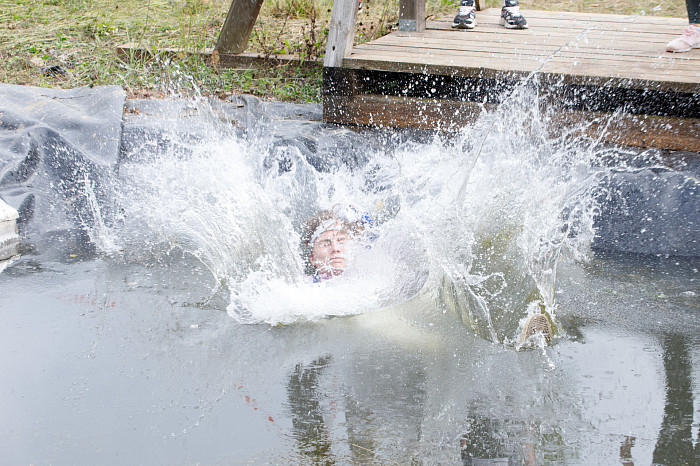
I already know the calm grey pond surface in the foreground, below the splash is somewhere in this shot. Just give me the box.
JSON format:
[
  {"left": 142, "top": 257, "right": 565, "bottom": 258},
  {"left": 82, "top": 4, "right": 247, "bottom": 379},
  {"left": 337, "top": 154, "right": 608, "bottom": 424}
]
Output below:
[{"left": 0, "top": 251, "right": 700, "bottom": 464}]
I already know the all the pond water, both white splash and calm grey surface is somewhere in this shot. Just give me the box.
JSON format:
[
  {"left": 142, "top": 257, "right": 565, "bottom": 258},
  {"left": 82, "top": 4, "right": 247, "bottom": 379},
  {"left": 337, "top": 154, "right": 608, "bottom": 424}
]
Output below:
[{"left": 0, "top": 85, "right": 700, "bottom": 464}]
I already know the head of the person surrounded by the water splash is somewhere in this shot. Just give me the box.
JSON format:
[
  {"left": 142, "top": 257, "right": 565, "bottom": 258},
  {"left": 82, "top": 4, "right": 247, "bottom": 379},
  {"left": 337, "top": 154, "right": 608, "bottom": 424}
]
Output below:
[{"left": 302, "top": 204, "right": 371, "bottom": 283}]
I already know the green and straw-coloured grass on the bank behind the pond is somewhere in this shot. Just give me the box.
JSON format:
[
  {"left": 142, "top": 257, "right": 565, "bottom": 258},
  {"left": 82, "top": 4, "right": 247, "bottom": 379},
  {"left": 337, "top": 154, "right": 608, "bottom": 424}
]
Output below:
[{"left": 0, "top": 0, "right": 686, "bottom": 102}]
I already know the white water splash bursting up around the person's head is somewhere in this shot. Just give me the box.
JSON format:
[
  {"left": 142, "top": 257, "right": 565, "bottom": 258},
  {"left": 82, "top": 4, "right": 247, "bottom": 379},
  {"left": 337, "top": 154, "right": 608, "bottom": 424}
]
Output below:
[{"left": 98, "top": 87, "right": 605, "bottom": 342}]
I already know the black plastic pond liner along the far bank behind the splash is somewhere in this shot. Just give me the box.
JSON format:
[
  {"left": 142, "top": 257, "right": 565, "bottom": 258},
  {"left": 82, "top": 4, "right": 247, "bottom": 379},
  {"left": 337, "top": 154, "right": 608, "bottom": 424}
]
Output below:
[{"left": 0, "top": 84, "right": 700, "bottom": 256}]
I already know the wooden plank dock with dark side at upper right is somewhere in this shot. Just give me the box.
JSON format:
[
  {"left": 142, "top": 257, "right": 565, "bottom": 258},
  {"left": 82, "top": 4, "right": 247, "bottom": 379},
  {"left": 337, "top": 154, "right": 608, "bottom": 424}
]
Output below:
[{"left": 323, "top": 8, "right": 700, "bottom": 152}]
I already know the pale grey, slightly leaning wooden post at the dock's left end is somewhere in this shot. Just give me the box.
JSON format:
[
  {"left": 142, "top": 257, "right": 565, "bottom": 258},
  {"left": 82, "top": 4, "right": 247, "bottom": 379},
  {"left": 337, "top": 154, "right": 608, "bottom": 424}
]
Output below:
[{"left": 323, "top": 0, "right": 357, "bottom": 68}]
